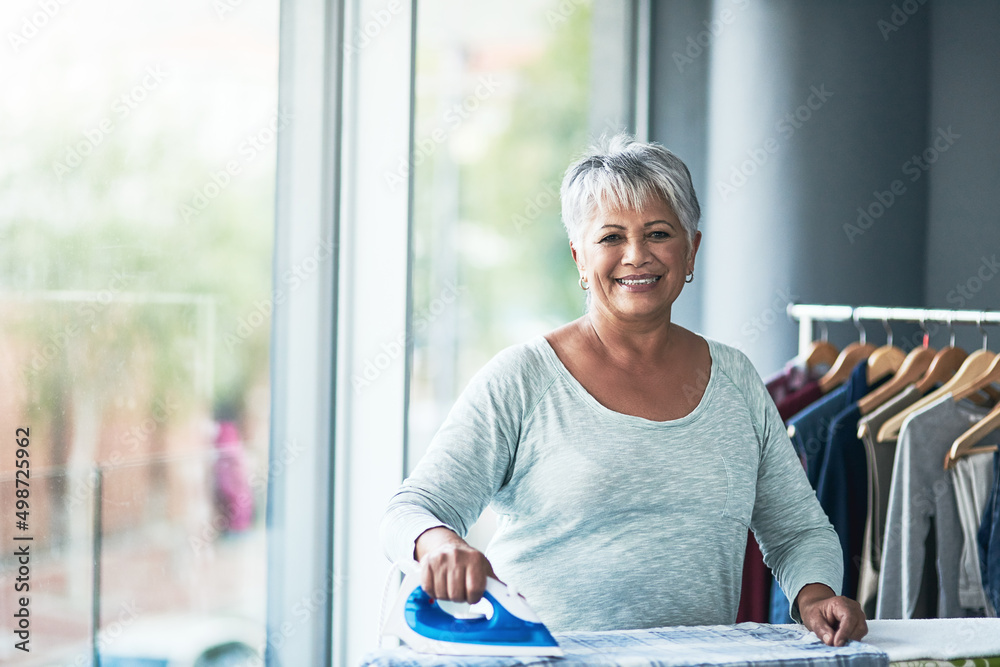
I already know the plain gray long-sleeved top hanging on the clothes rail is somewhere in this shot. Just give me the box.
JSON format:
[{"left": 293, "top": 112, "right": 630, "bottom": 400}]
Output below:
[{"left": 875, "top": 394, "right": 998, "bottom": 618}]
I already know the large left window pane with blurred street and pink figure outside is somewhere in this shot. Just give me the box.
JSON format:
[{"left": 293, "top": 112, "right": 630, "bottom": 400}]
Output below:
[{"left": 0, "top": 0, "right": 278, "bottom": 665}]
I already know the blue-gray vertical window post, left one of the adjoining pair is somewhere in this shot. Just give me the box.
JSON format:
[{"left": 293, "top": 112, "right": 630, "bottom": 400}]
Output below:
[{"left": 267, "top": 0, "right": 343, "bottom": 666}]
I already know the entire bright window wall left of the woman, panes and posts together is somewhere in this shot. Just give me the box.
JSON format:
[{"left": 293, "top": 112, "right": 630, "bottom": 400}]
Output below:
[{"left": 0, "top": 0, "right": 635, "bottom": 665}]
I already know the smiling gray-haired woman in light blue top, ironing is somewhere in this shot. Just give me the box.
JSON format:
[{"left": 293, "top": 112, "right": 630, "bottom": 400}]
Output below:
[{"left": 382, "top": 135, "right": 867, "bottom": 646}]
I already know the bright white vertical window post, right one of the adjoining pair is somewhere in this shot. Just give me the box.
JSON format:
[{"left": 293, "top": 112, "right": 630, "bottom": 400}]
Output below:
[{"left": 334, "top": 0, "right": 415, "bottom": 665}]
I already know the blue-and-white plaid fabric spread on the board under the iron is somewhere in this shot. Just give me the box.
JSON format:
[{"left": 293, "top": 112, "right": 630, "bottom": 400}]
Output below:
[{"left": 361, "top": 623, "right": 889, "bottom": 667}]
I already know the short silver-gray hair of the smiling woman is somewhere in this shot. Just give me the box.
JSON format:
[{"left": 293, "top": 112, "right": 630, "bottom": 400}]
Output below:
[{"left": 559, "top": 133, "right": 701, "bottom": 252}]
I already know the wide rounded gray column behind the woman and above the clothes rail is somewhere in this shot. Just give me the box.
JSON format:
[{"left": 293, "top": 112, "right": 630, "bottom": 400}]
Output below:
[{"left": 701, "top": 0, "right": 928, "bottom": 374}]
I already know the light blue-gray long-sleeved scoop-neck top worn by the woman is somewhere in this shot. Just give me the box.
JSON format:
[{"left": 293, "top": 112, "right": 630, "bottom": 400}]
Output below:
[{"left": 381, "top": 337, "right": 843, "bottom": 631}]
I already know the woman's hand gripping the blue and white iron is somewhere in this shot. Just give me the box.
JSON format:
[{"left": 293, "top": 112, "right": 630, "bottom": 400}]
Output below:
[{"left": 414, "top": 526, "right": 496, "bottom": 604}]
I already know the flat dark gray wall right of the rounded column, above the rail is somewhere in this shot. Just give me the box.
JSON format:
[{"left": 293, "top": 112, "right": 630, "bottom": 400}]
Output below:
[{"left": 921, "top": 0, "right": 1000, "bottom": 349}]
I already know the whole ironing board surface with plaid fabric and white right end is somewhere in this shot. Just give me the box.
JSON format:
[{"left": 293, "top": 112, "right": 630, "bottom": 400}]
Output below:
[{"left": 361, "top": 618, "right": 1000, "bottom": 667}]
